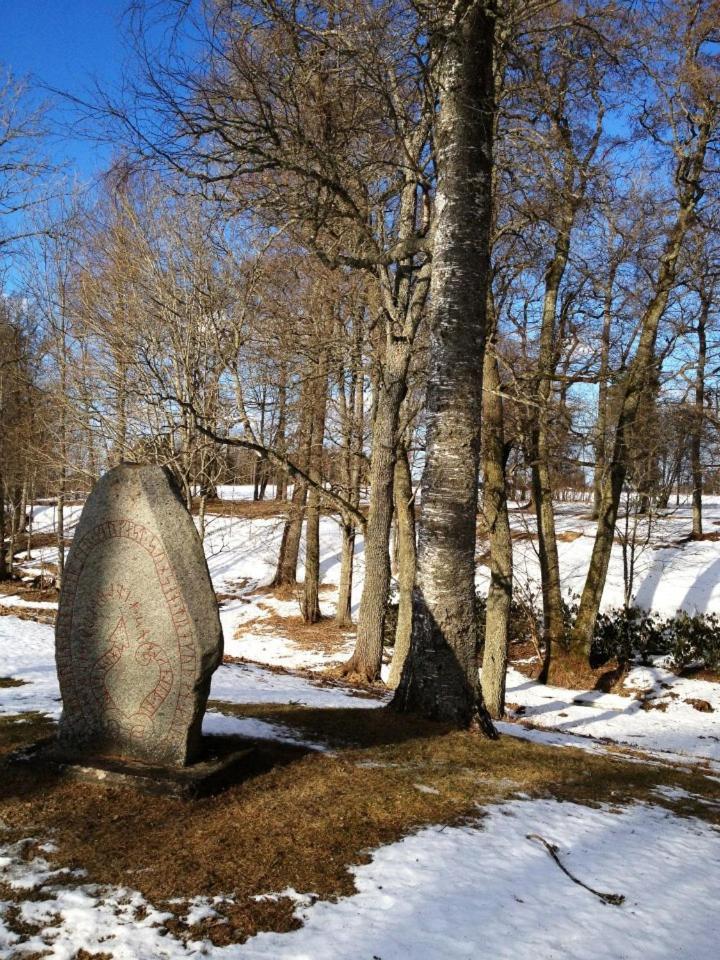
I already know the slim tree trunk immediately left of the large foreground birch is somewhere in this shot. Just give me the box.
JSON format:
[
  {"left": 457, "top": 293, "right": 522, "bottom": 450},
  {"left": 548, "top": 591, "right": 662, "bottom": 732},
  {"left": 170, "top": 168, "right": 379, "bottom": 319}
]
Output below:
[{"left": 387, "top": 444, "right": 417, "bottom": 690}]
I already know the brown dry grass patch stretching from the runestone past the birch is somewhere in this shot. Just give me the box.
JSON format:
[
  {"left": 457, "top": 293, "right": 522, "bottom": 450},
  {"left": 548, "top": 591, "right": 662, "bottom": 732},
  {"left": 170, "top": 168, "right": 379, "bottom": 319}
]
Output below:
[{"left": 0, "top": 704, "right": 720, "bottom": 944}]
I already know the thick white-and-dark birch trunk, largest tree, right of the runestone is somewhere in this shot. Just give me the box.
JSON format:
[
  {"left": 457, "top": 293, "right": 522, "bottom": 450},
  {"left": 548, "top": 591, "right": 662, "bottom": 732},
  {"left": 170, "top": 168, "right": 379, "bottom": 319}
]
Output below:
[{"left": 393, "top": 0, "right": 494, "bottom": 733}]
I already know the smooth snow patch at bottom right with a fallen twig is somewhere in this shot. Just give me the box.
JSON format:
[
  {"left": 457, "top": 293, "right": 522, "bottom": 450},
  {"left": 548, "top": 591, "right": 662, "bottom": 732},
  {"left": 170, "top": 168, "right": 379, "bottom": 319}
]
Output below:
[{"left": 232, "top": 800, "right": 720, "bottom": 960}]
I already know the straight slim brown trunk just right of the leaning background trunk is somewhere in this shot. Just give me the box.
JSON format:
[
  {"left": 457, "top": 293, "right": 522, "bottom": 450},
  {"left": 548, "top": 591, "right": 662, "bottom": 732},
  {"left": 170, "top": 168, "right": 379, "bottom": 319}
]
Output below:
[{"left": 302, "top": 348, "right": 328, "bottom": 623}]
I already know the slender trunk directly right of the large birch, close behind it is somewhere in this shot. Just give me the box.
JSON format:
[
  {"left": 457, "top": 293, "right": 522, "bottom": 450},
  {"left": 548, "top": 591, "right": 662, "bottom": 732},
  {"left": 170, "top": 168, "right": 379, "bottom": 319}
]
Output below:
[{"left": 480, "top": 334, "right": 513, "bottom": 719}]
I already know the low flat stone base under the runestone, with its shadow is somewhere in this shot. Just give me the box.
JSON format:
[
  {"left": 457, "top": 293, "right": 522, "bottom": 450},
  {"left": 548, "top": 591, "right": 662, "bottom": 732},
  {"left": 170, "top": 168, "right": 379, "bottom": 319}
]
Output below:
[{"left": 7, "top": 736, "right": 255, "bottom": 800}]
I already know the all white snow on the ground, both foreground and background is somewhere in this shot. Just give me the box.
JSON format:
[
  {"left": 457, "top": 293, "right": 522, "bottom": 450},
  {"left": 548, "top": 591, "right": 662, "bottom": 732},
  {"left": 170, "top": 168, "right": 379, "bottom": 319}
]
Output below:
[{"left": 0, "top": 488, "right": 720, "bottom": 960}]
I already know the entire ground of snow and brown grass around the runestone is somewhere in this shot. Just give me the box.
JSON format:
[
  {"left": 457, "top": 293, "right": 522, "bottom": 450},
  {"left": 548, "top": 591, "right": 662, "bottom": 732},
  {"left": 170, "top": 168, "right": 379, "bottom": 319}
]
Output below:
[{"left": 0, "top": 489, "right": 720, "bottom": 960}]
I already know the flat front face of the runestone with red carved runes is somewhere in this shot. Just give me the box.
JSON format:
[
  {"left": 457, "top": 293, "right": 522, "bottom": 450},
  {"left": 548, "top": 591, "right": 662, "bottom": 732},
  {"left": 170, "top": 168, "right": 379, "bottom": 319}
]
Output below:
[{"left": 57, "top": 518, "right": 197, "bottom": 758}]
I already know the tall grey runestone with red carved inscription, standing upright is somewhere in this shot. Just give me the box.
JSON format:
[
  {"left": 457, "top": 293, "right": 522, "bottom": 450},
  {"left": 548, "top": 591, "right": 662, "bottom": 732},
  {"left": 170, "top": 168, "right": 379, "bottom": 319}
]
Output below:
[{"left": 55, "top": 464, "right": 222, "bottom": 766}]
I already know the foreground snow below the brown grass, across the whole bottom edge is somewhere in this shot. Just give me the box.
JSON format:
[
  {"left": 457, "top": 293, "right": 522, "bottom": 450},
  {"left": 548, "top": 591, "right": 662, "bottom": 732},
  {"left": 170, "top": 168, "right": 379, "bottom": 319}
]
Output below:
[{"left": 0, "top": 800, "right": 720, "bottom": 960}]
